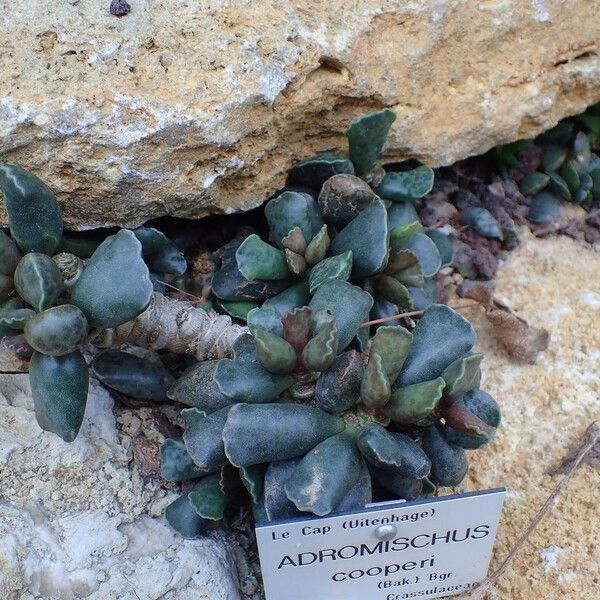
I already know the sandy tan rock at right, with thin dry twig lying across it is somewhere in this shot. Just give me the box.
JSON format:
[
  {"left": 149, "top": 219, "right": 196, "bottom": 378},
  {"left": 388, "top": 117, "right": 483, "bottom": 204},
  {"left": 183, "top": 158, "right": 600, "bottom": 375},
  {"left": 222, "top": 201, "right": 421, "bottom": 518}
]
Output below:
[{"left": 462, "top": 231, "right": 600, "bottom": 600}]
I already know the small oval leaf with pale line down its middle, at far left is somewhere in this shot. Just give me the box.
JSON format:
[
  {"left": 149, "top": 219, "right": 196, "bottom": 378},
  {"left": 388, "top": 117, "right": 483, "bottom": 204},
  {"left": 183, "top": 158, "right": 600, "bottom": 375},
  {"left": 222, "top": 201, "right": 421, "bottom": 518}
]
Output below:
[{"left": 14, "top": 252, "right": 63, "bottom": 312}]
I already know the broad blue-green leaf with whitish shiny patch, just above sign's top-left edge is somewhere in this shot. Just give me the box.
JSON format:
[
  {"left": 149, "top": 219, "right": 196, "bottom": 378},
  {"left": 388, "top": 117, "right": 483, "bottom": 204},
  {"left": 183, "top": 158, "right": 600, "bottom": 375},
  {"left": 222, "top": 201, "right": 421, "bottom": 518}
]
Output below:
[{"left": 285, "top": 432, "right": 362, "bottom": 516}]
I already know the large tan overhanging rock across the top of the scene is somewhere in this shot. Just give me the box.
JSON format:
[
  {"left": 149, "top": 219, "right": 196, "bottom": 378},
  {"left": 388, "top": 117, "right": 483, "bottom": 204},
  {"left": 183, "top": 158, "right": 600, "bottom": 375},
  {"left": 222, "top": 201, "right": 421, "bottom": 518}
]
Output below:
[{"left": 0, "top": 0, "right": 600, "bottom": 229}]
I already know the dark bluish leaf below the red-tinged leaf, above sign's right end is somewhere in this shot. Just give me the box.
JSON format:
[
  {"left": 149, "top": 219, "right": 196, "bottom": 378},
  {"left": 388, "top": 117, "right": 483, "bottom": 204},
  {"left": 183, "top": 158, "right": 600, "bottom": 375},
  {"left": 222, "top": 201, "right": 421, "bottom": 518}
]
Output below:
[{"left": 423, "top": 426, "right": 469, "bottom": 487}]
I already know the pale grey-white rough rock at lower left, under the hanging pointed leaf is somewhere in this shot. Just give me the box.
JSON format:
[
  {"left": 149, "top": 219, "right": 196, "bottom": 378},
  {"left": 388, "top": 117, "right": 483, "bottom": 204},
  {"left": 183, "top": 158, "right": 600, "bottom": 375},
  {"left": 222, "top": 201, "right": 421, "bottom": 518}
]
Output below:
[{"left": 0, "top": 375, "right": 240, "bottom": 600}]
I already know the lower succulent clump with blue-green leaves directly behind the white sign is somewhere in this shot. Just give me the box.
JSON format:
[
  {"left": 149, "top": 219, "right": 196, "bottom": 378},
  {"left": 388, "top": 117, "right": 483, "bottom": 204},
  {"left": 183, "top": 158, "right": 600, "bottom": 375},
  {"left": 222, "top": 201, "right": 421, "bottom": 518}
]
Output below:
[{"left": 161, "top": 302, "right": 500, "bottom": 537}]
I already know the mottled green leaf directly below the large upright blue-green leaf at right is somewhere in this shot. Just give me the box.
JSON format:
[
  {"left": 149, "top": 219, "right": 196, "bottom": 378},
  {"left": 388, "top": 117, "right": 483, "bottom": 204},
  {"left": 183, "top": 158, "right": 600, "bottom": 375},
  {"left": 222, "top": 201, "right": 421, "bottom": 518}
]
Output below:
[{"left": 386, "top": 377, "right": 445, "bottom": 425}]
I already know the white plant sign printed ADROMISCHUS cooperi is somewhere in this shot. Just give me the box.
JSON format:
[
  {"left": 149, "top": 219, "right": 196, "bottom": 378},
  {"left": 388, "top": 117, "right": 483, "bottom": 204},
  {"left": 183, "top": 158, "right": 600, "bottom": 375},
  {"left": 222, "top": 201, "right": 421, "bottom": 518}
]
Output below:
[{"left": 256, "top": 489, "right": 506, "bottom": 600}]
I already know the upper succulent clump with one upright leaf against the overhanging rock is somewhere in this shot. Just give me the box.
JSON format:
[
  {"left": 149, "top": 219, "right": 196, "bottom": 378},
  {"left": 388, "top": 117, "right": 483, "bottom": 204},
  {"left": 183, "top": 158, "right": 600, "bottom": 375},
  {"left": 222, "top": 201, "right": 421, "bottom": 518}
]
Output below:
[{"left": 212, "top": 109, "right": 452, "bottom": 330}]
